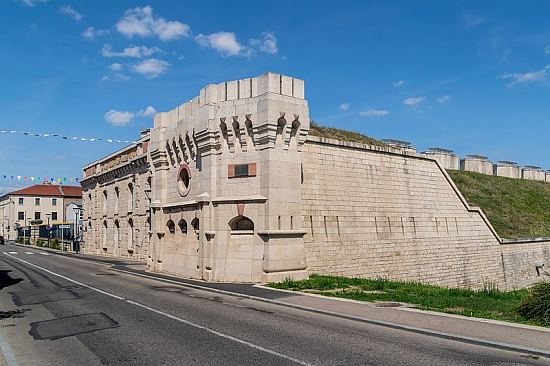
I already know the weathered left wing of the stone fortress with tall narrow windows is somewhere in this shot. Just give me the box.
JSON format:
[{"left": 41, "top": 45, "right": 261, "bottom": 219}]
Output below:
[{"left": 81, "top": 130, "right": 151, "bottom": 259}]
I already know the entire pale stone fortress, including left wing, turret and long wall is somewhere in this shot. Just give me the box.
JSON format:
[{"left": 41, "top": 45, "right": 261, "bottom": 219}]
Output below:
[{"left": 82, "top": 73, "right": 550, "bottom": 289}]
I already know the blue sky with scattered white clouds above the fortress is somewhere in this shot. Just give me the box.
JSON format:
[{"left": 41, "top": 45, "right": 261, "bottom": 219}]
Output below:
[{"left": 0, "top": 0, "right": 550, "bottom": 191}]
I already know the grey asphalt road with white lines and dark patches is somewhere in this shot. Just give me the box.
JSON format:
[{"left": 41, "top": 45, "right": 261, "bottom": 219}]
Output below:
[{"left": 0, "top": 244, "right": 550, "bottom": 366}]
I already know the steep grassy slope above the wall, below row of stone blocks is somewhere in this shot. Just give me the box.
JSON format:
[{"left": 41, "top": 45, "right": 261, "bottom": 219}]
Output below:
[{"left": 448, "top": 170, "right": 550, "bottom": 238}]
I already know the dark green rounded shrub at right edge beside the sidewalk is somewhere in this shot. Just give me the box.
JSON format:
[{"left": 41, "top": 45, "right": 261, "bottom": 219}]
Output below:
[{"left": 518, "top": 274, "right": 550, "bottom": 326}]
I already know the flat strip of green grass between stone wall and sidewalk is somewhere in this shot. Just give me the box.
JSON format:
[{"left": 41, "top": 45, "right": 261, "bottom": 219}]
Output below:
[{"left": 268, "top": 274, "right": 550, "bottom": 326}]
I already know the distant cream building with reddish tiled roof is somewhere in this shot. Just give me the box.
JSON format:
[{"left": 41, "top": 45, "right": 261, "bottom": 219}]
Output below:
[{"left": 0, "top": 183, "right": 82, "bottom": 240}]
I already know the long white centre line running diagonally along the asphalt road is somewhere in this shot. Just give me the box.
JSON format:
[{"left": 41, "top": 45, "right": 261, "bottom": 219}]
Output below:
[{"left": 4, "top": 252, "right": 311, "bottom": 366}]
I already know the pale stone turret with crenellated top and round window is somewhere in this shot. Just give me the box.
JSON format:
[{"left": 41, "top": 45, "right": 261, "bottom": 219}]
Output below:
[{"left": 150, "top": 73, "right": 310, "bottom": 282}]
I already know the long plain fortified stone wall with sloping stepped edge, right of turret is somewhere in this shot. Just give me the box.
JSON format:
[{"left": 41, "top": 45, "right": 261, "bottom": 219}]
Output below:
[{"left": 302, "top": 136, "right": 550, "bottom": 289}]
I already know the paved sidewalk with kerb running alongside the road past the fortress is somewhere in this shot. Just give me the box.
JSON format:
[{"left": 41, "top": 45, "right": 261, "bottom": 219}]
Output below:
[{"left": 11, "top": 245, "right": 550, "bottom": 358}]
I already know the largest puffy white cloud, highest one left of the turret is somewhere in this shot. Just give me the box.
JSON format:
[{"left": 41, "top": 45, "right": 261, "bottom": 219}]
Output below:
[{"left": 116, "top": 5, "right": 190, "bottom": 41}]
